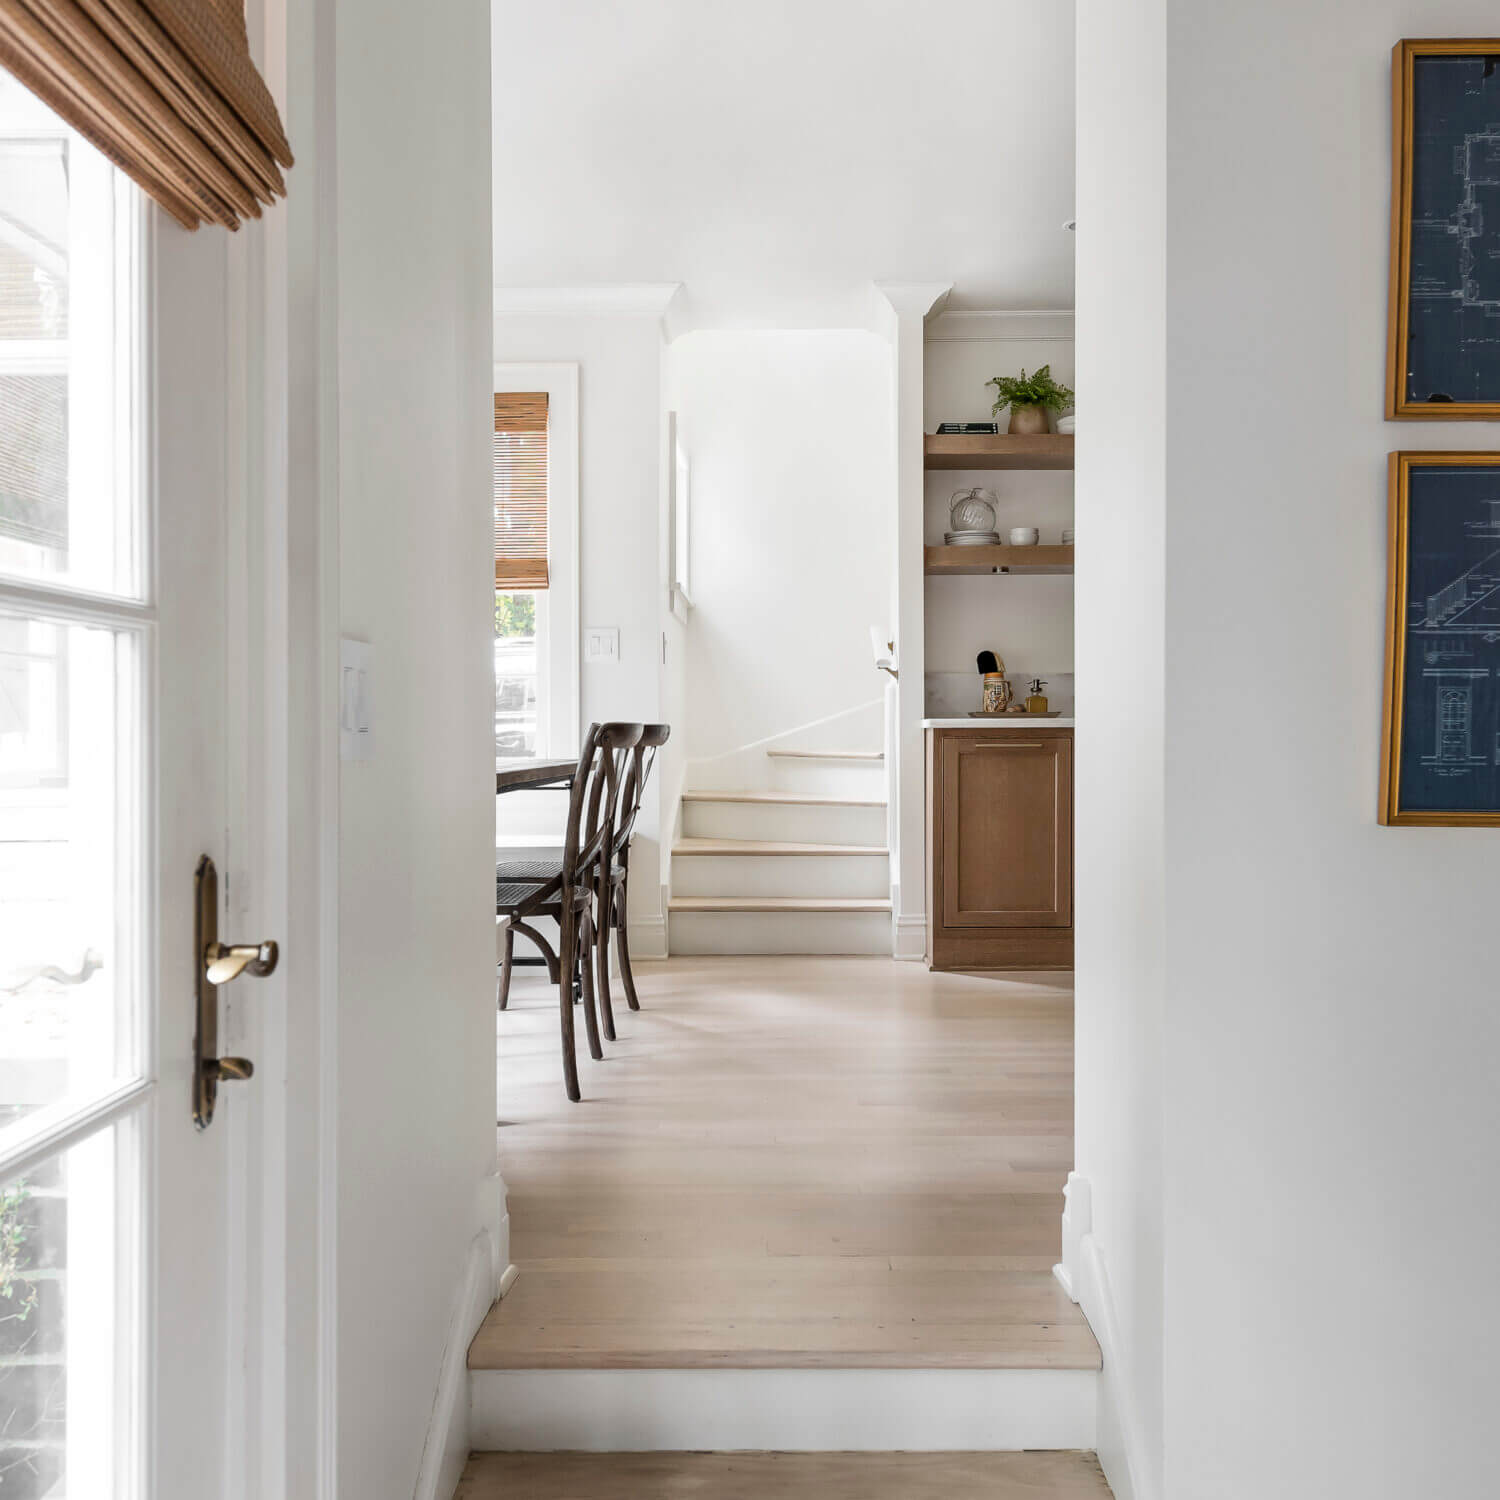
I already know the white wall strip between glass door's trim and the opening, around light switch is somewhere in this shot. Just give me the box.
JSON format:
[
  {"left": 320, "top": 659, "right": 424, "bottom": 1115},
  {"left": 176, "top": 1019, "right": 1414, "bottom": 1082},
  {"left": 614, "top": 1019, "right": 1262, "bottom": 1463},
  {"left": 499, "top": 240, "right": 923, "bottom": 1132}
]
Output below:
[{"left": 334, "top": 0, "right": 495, "bottom": 1500}]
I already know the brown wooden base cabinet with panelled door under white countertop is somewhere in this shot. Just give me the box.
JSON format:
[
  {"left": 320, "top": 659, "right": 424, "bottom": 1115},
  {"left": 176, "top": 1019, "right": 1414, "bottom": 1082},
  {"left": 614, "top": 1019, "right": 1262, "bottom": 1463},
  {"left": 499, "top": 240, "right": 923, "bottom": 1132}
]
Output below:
[{"left": 927, "top": 725, "right": 1073, "bottom": 969}]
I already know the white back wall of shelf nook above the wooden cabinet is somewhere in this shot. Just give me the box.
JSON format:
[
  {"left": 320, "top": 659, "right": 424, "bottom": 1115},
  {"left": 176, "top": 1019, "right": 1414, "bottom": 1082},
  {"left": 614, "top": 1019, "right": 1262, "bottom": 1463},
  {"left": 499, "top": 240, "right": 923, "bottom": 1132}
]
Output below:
[{"left": 924, "top": 312, "right": 1074, "bottom": 714}]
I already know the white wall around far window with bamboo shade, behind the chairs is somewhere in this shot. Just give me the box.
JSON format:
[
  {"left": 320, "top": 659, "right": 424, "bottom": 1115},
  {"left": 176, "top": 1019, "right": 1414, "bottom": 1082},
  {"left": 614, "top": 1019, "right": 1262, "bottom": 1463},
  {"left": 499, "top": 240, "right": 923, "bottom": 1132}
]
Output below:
[{"left": 495, "top": 298, "right": 675, "bottom": 957}]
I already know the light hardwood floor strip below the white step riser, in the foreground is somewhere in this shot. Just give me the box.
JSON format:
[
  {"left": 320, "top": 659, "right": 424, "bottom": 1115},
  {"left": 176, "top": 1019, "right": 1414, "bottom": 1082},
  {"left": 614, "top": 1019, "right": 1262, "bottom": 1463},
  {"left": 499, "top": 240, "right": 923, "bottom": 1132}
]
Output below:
[{"left": 456, "top": 1454, "right": 1110, "bottom": 1500}]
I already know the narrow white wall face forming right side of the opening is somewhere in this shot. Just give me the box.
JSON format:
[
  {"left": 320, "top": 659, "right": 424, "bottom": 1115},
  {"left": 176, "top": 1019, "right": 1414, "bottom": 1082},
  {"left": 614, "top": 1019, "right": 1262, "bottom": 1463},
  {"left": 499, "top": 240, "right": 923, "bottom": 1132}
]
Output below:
[{"left": 1074, "top": 0, "right": 1164, "bottom": 1500}]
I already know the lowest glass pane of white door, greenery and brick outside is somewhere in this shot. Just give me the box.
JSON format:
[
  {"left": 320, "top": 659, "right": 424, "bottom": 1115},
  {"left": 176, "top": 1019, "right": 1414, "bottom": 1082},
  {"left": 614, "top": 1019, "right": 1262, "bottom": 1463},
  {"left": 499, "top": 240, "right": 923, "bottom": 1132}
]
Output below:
[{"left": 0, "top": 1130, "right": 132, "bottom": 1500}]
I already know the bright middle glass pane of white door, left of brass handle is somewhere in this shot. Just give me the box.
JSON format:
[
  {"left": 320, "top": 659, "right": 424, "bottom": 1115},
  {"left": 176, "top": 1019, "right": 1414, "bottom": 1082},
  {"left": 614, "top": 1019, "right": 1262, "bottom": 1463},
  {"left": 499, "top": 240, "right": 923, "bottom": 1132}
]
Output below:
[{"left": 0, "top": 611, "right": 141, "bottom": 1140}]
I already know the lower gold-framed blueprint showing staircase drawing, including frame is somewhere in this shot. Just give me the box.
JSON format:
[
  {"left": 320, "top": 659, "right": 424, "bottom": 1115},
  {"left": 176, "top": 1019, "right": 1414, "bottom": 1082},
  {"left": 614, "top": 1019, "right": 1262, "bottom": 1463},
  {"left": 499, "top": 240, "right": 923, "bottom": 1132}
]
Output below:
[{"left": 1380, "top": 453, "right": 1500, "bottom": 827}]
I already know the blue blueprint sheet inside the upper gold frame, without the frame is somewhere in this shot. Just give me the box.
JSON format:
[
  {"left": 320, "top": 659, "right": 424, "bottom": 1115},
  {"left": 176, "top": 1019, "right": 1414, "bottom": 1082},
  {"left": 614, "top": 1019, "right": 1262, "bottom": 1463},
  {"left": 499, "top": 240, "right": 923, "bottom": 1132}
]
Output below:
[{"left": 1406, "top": 56, "right": 1500, "bottom": 402}]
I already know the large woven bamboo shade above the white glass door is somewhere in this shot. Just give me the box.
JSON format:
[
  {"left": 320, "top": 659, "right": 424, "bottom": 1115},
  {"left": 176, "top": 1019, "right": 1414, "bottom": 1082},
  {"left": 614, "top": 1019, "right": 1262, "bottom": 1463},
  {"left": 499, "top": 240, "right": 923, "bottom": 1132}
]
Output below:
[{"left": 0, "top": 0, "right": 291, "bottom": 230}]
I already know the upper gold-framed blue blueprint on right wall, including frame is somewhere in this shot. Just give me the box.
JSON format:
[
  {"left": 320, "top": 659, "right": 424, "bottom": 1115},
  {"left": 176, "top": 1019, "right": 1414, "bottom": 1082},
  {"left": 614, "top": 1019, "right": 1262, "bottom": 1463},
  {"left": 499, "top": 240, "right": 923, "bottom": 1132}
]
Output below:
[{"left": 1386, "top": 39, "right": 1500, "bottom": 422}]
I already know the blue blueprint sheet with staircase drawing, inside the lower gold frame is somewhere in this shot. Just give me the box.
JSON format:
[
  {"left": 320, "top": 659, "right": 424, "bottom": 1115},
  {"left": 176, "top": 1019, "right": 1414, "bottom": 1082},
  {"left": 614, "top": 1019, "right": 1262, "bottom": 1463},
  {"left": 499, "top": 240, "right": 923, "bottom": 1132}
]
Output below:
[{"left": 1400, "top": 465, "right": 1500, "bottom": 812}]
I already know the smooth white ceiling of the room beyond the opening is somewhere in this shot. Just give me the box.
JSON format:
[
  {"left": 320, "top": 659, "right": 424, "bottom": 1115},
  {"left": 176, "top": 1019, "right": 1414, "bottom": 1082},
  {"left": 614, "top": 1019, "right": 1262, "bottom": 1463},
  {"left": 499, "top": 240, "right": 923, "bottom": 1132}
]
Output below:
[{"left": 494, "top": 0, "right": 1073, "bottom": 327}]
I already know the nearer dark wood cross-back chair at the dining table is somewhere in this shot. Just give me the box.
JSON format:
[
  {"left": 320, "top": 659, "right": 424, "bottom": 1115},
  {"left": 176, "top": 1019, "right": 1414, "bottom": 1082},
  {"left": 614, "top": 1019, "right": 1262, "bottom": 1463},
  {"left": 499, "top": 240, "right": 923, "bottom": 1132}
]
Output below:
[{"left": 495, "top": 723, "right": 645, "bottom": 1103}]
